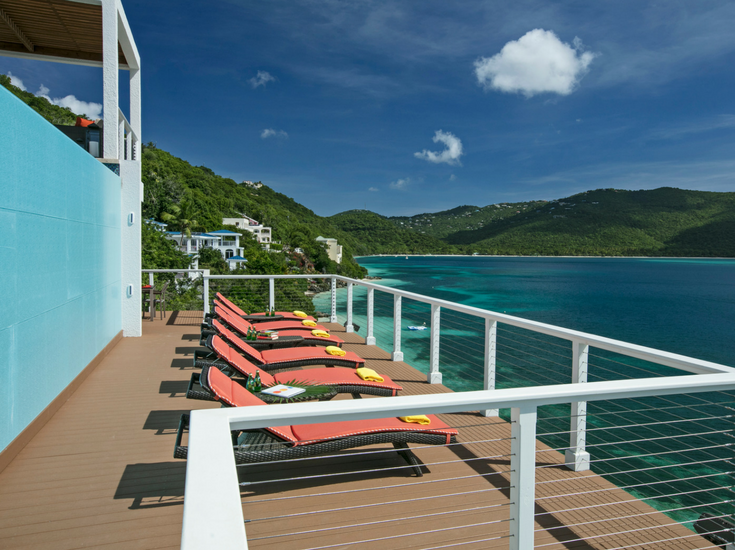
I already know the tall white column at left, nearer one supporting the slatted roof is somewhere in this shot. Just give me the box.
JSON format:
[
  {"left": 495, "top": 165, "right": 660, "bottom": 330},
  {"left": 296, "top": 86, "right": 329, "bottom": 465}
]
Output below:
[{"left": 102, "top": 0, "right": 117, "bottom": 161}]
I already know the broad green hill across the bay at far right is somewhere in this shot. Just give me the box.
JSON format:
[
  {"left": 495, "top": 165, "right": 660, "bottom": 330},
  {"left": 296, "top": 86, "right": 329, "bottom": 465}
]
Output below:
[{"left": 446, "top": 187, "right": 735, "bottom": 257}]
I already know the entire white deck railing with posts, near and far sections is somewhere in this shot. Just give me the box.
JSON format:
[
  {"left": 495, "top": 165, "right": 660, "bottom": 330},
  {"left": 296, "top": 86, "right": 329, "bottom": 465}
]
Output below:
[{"left": 182, "top": 274, "right": 735, "bottom": 549}]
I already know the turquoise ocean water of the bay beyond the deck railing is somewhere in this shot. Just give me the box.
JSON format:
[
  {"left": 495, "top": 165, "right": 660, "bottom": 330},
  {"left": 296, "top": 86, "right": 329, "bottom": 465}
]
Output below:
[{"left": 315, "top": 256, "right": 735, "bottom": 526}]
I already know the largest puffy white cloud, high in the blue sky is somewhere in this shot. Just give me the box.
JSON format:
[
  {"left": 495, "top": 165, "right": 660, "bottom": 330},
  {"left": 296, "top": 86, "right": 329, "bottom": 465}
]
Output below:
[{"left": 475, "top": 29, "right": 597, "bottom": 97}]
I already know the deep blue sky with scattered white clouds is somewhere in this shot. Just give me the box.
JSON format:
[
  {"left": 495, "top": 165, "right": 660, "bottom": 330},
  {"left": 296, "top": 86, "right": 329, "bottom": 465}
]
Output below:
[{"left": 0, "top": 0, "right": 735, "bottom": 216}]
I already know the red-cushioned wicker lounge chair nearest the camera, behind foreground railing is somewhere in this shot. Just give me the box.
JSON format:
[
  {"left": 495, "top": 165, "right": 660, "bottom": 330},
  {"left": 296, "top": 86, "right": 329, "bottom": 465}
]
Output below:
[{"left": 174, "top": 369, "right": 458, "bottom": 477}]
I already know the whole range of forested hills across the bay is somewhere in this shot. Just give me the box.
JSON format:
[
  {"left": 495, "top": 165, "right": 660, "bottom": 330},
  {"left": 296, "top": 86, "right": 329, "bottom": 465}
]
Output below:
[{"left": 331, "top": 187, "right": 735, "bottom": 257}]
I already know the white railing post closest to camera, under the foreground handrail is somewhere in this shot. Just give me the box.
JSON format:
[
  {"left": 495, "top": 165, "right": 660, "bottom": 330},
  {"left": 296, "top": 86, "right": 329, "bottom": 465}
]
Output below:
[{"left": 510, "top": 405, "right": 537, "bottom": 550}]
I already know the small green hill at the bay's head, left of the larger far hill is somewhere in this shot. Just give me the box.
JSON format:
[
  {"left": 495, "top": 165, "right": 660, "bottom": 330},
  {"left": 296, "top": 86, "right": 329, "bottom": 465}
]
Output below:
[{"left": 327, "top": 210, "right": 454, "bottom": 254}]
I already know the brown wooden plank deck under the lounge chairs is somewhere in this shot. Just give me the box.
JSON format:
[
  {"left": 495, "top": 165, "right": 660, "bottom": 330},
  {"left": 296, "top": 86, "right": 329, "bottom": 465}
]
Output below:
[{"left": 0, "top": 312, "right": 716, "bottom": 550}]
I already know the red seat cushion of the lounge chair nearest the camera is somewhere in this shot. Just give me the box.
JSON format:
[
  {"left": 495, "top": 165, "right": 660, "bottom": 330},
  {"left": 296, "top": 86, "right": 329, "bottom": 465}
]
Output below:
[{"left": 291, "top": 415, "right": 458, "bottom": 445}]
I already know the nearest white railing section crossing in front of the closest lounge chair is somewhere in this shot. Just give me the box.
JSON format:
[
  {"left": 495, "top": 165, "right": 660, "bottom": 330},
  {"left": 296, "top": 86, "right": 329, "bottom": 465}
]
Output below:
[{"left": 181, "top": 373, "right": 735, "bottom": 550}]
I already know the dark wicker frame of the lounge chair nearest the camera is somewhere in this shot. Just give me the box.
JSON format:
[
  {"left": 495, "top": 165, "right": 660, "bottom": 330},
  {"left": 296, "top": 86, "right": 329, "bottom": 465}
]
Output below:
[{"left": 174, "top": 369, "right": 457, "bottom": 477}]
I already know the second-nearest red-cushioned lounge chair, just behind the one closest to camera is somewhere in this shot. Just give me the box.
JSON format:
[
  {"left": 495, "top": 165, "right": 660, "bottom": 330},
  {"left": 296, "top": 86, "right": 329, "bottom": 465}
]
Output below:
[{"left": 187, "top": 336, "right": 403, "bottom": 399}]
